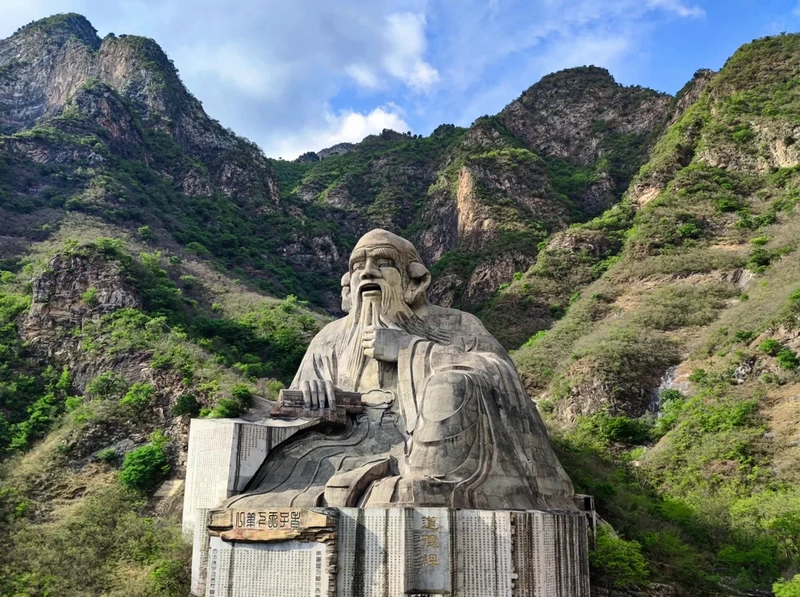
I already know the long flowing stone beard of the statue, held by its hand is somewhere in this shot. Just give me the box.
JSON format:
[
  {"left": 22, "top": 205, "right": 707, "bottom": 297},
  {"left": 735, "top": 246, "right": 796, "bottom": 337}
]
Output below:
[{"left": 343, "top": 280, "right": 449, "bottom": 389}]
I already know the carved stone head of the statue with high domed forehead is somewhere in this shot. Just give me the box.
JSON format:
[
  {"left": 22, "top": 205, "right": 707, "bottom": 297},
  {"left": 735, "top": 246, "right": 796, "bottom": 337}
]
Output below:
[{"left": 342, "top": 228, "right": 431, "bottom": 316}]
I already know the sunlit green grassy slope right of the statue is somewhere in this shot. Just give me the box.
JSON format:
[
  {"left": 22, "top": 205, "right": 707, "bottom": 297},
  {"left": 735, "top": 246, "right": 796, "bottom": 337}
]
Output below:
[{"left": 514, "top": 35, "right": 800, "bottom": 594}]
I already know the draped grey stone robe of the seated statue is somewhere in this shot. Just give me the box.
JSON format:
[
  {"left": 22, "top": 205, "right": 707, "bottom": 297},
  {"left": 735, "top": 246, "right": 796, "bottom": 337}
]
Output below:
[{"left": 228, "top": 306, "right": 575, "bottom": 509}]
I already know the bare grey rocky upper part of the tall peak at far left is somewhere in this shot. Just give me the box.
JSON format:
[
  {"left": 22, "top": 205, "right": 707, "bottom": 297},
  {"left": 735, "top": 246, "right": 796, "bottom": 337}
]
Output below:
[{"left": 0, "top": 14, "right": 279, "bottom": 203}]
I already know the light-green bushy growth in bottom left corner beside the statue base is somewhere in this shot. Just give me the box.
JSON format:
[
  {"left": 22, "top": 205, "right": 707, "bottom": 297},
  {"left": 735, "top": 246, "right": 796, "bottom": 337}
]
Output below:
[{"left": 0, "top": 485, "right": 191, "bottom": 597}]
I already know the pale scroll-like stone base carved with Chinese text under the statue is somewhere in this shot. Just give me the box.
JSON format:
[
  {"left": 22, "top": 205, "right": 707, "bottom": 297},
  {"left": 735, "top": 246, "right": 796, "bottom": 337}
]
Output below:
[{"left": 194, "top": 508, "right": 590, "bottom": 597}]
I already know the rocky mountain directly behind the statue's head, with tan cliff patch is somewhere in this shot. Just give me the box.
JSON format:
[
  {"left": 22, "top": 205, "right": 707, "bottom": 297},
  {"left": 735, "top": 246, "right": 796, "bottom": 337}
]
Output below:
[{"left": 274, "top": 67, "right": 671, "bottom": 310}]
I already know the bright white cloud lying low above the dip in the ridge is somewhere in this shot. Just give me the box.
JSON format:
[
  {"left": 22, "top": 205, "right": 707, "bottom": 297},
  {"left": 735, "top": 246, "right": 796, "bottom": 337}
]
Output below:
[{"left": 265, "top": 105, "right": 410, "bottom": 159}]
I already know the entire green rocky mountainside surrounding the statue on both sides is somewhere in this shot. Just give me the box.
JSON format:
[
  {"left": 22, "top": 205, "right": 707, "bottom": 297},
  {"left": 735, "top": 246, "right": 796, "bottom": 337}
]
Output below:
[{"left": 0, "top": 14, "right": 800, "bottom": 597}]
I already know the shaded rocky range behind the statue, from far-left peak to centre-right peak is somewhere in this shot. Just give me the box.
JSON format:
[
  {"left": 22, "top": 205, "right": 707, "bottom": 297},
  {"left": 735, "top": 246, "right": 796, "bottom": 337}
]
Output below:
[{"left": 0, "top": 14, "right": 671, "bottom": 310}]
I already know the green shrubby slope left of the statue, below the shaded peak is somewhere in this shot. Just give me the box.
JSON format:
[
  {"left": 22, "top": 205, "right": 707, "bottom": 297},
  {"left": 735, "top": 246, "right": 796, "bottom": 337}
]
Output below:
[{"left": 0, "top": 215, "right": 323, "bottom": 597}]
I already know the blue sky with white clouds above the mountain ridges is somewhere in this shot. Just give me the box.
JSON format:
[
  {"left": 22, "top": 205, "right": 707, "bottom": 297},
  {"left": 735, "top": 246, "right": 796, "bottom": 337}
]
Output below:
[{"left": 0, "top": 0, "right": 800, "bottom": 159}]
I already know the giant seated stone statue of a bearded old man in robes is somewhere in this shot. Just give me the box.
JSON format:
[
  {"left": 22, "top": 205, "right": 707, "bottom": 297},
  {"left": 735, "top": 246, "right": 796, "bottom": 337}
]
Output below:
[{"left": 226, "top": 229, "right": 575, "bottom": 510}]
